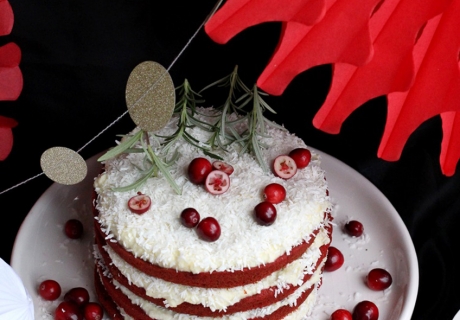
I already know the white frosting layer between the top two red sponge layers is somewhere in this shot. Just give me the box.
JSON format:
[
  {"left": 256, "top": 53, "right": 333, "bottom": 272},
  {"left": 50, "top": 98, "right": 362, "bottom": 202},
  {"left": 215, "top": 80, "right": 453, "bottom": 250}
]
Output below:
[{"left": 105, "top": 226, "right": 330, "bottom": 311}]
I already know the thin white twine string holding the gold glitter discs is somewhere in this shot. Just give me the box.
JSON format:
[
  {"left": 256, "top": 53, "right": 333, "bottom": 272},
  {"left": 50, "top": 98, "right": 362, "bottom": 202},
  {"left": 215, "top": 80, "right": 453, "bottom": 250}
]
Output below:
[{"left": 0, "top": 0, "right": 223, "bottom": 195}]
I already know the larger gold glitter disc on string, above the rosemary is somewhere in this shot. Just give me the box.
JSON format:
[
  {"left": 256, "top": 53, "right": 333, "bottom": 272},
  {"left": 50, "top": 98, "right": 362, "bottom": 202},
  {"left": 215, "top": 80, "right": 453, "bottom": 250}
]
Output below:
[{"left": 126, "top": 61, "right": 176, "bottom": 131}]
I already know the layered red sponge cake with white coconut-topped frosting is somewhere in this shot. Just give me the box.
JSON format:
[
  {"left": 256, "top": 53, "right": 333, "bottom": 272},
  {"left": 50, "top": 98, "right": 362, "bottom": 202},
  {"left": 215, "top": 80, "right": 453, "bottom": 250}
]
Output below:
[{"left": 93, "top": 108, "right": 332, "bottom": 320}]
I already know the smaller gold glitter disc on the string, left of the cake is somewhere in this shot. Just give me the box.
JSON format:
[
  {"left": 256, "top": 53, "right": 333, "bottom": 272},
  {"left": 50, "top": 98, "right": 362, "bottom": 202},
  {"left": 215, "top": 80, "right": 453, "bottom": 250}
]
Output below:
[{"left": 40, "top": 147, "right": 88, "bottom": 185}]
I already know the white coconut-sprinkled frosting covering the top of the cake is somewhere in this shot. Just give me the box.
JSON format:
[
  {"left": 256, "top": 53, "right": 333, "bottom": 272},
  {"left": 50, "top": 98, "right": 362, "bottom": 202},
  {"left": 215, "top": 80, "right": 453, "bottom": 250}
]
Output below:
[{"left": 94, "top": 109, "right": 332, "bottom": 273}]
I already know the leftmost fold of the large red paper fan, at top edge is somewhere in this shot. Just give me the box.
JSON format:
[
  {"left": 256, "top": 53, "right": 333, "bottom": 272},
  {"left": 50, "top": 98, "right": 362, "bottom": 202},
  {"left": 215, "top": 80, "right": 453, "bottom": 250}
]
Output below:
[{"left": 204, "top": 0, "right": 325, "bottom": 44}]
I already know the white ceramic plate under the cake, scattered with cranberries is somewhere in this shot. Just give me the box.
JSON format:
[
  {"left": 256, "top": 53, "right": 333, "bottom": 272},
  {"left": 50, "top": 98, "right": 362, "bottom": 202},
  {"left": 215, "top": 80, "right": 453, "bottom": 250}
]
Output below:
[{"left": 11, "top": 151, "right": 418, "bottom": 320}]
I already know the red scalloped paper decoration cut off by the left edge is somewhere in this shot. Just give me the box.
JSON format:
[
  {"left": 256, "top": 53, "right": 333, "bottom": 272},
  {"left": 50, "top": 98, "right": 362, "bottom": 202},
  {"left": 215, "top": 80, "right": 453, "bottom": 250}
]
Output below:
[{"left": 0, "top": 0, "right": 23, "bottom": 161}]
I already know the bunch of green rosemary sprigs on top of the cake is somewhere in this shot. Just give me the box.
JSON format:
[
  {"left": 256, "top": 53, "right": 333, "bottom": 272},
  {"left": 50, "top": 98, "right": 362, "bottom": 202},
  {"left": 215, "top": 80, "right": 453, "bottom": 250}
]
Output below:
[{"left": 98, "top": 66, "right": 285, "bottom": 194}]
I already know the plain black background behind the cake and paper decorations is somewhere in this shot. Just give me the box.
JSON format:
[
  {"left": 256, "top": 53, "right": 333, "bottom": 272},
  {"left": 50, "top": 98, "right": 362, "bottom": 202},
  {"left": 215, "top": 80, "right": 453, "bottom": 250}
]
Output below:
[{"left": 0, "top": 0, "right": 460, "bottom": 320}]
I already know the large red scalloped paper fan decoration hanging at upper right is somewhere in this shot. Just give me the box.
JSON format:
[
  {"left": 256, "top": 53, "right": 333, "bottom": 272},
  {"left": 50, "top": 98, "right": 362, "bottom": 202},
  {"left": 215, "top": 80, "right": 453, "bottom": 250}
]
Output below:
[{"left": 205, "top": 0, "right": 460, "bottom": 176}]
